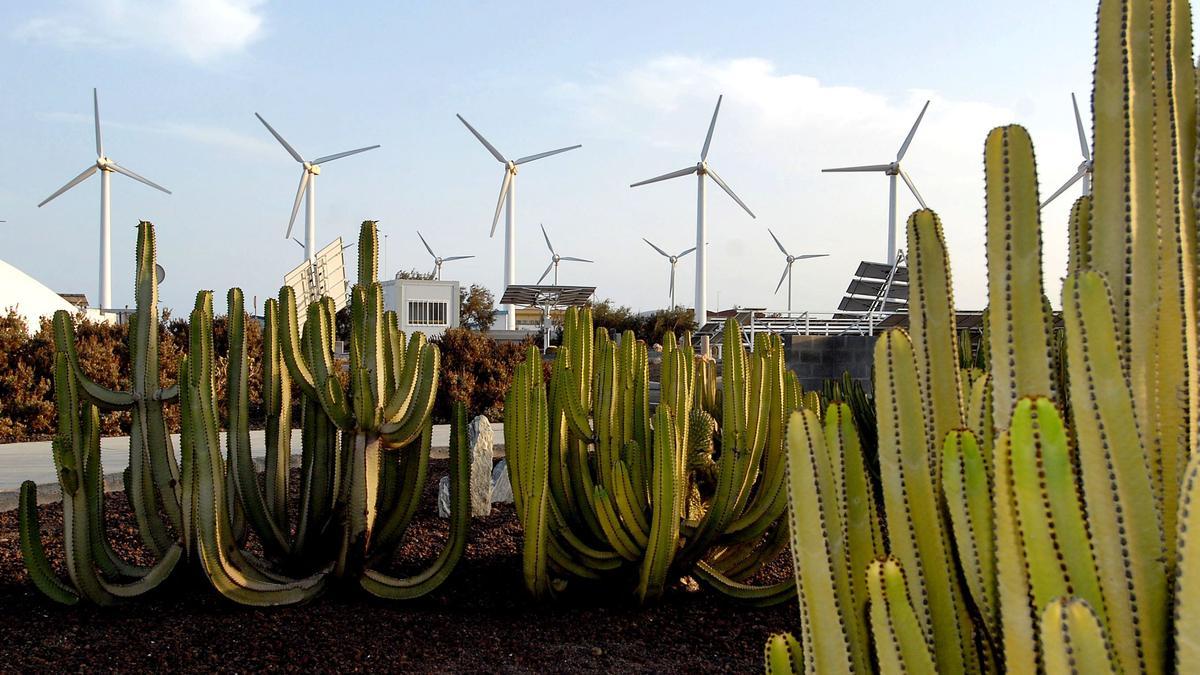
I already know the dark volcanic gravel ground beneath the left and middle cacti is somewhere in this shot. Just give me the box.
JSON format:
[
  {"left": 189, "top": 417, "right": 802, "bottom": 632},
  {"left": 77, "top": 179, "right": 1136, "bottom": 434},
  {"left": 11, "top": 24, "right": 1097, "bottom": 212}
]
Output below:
[{"left": 0, "top": 461, "right": 799, "bottom": 673}]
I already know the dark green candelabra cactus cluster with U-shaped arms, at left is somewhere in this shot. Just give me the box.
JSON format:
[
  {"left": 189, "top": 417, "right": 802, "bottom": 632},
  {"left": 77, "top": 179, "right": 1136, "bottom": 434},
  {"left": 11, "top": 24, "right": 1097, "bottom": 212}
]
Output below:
[{"left": 19, "top": 221, "right": 469, "bottom": 605}]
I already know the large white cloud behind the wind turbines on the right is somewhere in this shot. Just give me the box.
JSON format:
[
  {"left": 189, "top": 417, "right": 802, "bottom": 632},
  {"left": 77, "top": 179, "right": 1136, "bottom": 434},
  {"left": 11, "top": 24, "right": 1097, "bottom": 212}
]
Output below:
[{"left": 553, "top": 55, "right": 1078, "bottom": 311}]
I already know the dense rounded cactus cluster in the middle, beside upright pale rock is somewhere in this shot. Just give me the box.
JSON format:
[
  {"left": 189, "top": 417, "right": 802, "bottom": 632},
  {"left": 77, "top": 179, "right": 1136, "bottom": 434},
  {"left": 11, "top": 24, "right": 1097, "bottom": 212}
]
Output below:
[{"left": 504, "top": 309, "right": 801, "bottom": 604}]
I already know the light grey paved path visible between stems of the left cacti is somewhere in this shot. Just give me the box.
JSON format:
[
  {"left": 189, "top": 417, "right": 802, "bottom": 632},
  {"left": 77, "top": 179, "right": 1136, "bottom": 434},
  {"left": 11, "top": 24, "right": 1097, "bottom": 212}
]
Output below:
[{"left": 0, "top": 424, "right": 504, "bottom": 491}]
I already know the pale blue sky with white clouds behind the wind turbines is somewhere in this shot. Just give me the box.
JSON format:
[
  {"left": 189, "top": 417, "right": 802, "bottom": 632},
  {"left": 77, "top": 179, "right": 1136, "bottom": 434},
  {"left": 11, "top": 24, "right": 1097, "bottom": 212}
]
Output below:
[{"left": 0, "top": 0, "right": 1118, "bottom": 315}]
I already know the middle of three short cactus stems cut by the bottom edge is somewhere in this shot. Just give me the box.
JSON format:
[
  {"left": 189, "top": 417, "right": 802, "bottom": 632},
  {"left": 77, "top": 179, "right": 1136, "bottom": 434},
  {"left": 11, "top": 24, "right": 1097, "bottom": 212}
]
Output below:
[{"left": 866, "top": 557, "right": 937, "bottom": 675}]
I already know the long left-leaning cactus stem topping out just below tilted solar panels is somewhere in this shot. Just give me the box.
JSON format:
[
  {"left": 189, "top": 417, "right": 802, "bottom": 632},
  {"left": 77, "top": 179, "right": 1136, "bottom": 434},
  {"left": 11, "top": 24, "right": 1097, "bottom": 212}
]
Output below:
[{"left": 875, "top": 329, "right": 965, "bottom": 671}]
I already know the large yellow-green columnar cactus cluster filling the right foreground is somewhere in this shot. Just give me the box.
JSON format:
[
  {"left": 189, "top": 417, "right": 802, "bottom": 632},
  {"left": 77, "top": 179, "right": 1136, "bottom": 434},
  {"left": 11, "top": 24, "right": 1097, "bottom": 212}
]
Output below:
[{"left": 766, "top": 0, "right": 1200, "bottom": 674}]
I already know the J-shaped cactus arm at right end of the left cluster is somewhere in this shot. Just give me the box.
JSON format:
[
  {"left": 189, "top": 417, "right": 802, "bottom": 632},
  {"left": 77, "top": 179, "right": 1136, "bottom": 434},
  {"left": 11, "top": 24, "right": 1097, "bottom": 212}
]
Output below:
[{"left": 360, "top": 401, "right": 470, "bottom": 599}]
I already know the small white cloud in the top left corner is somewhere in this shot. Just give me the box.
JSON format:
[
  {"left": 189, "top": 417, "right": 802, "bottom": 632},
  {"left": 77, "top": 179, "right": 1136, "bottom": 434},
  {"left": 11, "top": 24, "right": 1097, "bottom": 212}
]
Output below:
[{"left": 12, "top": 0, "right": 265, "bottom": 62}]
